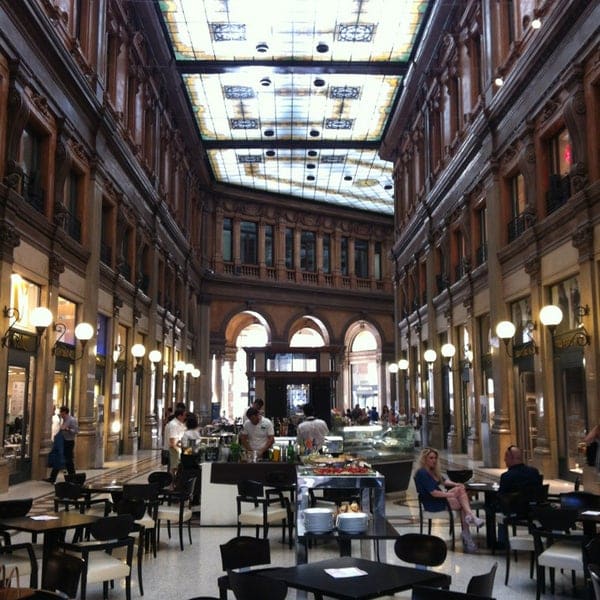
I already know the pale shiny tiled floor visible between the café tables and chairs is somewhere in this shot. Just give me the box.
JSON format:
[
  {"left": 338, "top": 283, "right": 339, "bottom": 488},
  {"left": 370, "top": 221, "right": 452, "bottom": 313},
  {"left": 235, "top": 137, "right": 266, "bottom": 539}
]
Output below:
[{"left": 0, "top": 452, "right": 586, "bottom": 600}]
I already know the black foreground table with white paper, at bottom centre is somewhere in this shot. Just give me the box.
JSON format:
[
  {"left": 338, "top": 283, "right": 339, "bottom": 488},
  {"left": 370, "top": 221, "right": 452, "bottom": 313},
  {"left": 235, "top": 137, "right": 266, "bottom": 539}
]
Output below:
[{"left": 260, "top": 556, "right": 451, "bottom": 600}]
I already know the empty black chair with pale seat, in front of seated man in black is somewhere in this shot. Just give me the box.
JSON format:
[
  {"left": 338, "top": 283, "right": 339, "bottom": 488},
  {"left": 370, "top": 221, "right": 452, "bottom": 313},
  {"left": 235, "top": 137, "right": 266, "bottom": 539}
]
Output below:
[{"left": 531, "top": 506, "right": 587, "bottom": 600}]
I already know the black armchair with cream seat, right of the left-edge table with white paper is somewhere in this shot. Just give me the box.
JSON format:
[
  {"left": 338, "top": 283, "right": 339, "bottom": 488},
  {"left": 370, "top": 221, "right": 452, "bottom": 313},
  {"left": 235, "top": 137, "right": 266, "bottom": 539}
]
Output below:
[{"left": 58, "top": 515, "right": 135, "bottom": 600}]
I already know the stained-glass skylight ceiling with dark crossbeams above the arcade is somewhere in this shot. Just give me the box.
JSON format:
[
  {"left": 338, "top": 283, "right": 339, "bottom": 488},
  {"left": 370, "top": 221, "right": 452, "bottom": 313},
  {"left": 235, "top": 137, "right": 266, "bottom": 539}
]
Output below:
[{"left": 157, "top": 0, "right": 431, "bottom": 214}]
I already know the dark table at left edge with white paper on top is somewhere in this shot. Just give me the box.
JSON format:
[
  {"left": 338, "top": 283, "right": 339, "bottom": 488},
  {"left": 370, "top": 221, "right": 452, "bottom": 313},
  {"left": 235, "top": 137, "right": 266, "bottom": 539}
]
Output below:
[{"left": 0, "top": 511, "right": 98, "bottom": 587}]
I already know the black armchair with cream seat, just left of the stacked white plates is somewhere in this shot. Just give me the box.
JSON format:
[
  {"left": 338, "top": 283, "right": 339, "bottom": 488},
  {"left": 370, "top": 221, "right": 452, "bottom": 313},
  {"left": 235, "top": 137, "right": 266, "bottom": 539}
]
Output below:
[{"left": 236, "top": 480, "right": 293, "bottom": 548}]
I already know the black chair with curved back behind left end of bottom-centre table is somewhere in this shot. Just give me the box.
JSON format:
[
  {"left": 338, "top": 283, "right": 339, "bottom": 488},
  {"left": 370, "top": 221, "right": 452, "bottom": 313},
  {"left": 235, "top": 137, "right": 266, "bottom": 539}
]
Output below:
[{"left": 217, "top": 535, "right": 278, "bottom": 600}]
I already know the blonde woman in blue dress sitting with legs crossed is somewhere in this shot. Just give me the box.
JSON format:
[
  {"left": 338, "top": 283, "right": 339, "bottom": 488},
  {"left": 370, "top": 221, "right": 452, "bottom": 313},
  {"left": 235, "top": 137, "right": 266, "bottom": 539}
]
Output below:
[{"left": 415, "top": 448, "right": 485, "bottom": 552}]
